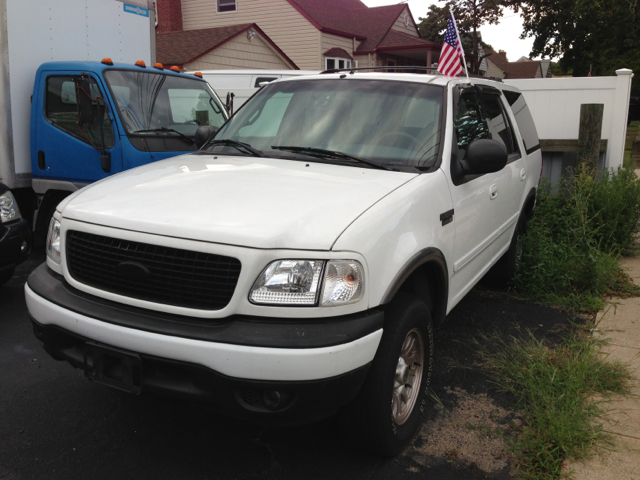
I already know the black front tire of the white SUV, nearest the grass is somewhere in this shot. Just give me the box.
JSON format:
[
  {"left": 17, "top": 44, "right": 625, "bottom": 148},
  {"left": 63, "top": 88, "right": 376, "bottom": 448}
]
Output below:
[{"left": 340, "top": 293, "right": 433, "bottom": 457}]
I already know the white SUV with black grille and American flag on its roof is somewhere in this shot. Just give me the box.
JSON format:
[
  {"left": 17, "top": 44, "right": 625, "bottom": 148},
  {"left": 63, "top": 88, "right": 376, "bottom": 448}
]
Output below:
[{"left": 25, "top": 71, "right": 542, "bottom": 455}]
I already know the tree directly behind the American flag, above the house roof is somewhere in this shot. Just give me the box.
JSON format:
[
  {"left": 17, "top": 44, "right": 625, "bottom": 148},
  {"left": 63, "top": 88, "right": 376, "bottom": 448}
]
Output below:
[{"left": 418, "top": 0, "right": 513, "bottom": 74}]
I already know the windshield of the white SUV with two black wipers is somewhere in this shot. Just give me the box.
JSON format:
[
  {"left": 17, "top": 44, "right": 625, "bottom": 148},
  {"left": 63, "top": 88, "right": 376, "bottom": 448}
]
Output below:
[{"left": 208, "top": 78, "right": 444, "bottom": 168}]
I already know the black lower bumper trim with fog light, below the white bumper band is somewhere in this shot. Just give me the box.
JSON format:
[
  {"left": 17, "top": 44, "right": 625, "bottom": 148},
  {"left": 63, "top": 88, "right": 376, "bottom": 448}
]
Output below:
[{"left": 31, "top": 318, "right": 370, "bottom": 425}]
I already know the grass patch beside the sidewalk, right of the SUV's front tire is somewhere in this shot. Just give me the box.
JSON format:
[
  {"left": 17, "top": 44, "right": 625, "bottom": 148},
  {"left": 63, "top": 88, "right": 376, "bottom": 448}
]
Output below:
[{"left": 478, "top": 327, "right": 630, "bottom": 479}]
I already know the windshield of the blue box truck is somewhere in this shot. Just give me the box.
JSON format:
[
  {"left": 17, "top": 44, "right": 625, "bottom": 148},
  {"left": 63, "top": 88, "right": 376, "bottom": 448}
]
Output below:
[{"left": 104, "top": 70, "right": 227, "bottom": 136}]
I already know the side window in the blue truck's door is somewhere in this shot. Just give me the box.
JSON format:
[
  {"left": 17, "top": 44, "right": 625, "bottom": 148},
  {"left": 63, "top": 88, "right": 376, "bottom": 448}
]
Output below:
[{"left": 45, "top": 76, "right": 115, "bottom": 148}]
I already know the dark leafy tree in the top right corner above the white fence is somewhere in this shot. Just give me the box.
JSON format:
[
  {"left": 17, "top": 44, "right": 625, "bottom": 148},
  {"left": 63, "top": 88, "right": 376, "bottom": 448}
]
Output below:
[{"left": 512, "top": 0, "right": 640, "bottom": 94}]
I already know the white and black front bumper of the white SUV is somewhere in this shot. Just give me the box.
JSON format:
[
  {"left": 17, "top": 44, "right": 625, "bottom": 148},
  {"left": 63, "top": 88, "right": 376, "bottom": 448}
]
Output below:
[{"left": 25, "top": 265, "right": 384, "bottom": 424}]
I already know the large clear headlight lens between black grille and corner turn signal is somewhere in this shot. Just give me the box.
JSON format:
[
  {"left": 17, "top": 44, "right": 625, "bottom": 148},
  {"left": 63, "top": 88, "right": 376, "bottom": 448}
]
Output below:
[{"left": 249, "top": 260, "right": 324, "bottom": 305}]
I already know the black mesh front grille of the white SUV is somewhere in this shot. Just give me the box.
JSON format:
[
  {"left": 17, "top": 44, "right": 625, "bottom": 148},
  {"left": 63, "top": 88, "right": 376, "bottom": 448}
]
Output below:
[{"left": 66, "top": 230, "right": 241, "bottom": 310}]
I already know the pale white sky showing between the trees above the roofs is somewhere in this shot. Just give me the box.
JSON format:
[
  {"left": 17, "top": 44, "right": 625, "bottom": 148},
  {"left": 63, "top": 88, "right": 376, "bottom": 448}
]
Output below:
[{"left": 362, "top": 0, "right": 533, "bottom": 62}]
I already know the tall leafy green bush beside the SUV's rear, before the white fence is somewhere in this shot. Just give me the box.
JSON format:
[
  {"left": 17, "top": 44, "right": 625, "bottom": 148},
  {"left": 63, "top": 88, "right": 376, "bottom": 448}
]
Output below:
[{"left": 514, "top": 168, "right": 640, "bottom": 311}]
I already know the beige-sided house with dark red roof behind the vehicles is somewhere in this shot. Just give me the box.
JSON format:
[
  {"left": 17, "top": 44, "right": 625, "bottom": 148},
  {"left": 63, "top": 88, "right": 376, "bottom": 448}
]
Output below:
[{"left": 156, "top": 0, "right": 441, "bottom": 70}]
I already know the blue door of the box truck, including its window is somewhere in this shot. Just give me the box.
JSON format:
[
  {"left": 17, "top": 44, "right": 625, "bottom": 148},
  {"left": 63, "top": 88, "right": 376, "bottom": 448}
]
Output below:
[{"left": 32, "top": 72, "right": 122, "bottom": 184}]
